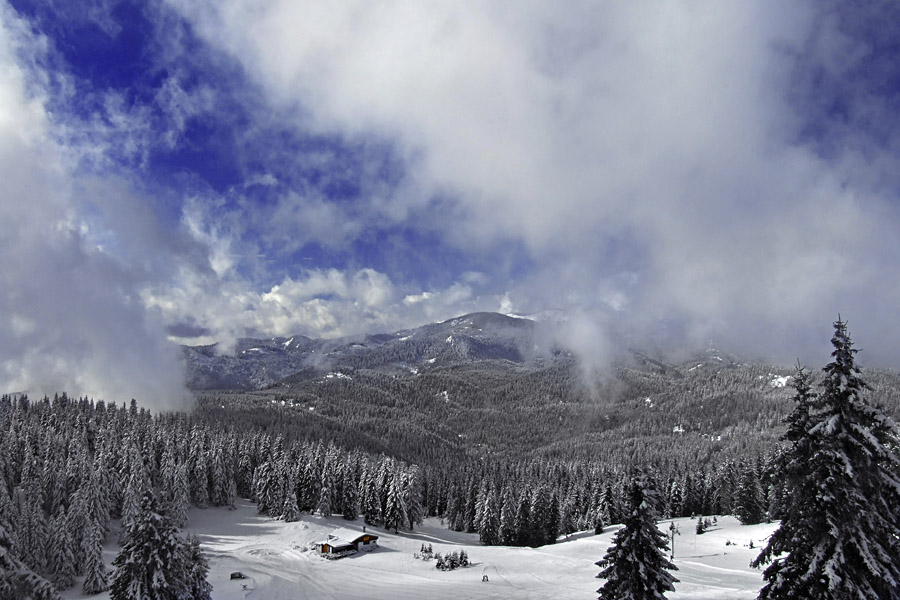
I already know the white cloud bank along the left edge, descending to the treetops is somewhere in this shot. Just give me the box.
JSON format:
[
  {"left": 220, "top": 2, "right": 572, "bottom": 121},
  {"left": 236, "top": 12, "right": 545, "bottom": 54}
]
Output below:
[{"left": 0, "top": 10, "right": 187, "bottom": 408}]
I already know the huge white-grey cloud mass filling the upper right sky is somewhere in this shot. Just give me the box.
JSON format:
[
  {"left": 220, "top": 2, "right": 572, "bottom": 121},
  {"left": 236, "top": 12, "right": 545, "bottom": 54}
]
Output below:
[{"left": 167, "top": 0, "right": 900, "bottom": 364}]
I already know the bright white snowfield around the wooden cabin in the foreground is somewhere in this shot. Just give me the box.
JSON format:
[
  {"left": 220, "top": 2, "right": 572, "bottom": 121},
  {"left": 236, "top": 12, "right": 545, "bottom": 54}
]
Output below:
[{"left": 63, "top": 500, "right": 776, "bottom": 600}]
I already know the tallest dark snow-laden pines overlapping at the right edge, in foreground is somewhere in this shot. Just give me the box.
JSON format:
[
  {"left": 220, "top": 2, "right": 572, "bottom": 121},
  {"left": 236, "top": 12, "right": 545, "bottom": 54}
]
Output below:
[{"left": 753, "top": 317, "right": 900, "bottom": 600}]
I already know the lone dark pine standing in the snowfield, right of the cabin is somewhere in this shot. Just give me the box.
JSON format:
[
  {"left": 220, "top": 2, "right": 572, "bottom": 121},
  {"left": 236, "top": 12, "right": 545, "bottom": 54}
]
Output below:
[{"left": 596, "top": 476, "right": 678, "bottom": 600}]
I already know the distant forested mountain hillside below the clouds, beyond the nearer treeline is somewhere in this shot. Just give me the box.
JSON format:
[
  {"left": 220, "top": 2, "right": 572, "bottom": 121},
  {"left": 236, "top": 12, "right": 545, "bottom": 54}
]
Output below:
[{"left": 185, "top": 313, "right": 900, "bottom": 466}]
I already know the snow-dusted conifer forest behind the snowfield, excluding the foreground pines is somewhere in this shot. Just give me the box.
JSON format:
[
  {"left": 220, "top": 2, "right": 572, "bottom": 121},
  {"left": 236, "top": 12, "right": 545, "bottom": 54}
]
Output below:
[{"left": 0, "top": 322, "right": 900, "bottom": 598}]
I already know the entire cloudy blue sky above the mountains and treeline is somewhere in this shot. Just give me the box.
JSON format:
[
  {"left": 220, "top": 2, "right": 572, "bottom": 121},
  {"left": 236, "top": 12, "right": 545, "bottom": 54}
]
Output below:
[{"left": 0, "top": 0, "right": 900, "bottom": 406}]
